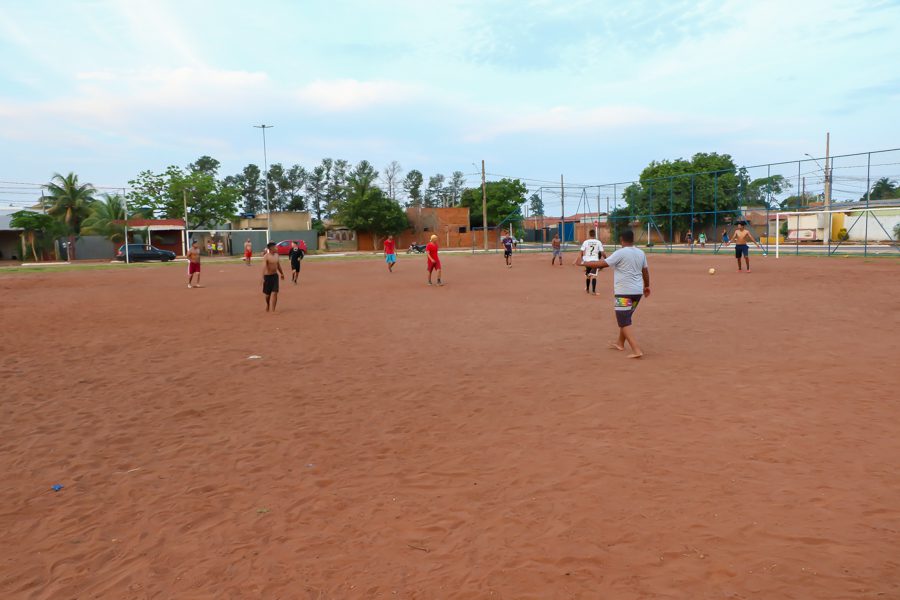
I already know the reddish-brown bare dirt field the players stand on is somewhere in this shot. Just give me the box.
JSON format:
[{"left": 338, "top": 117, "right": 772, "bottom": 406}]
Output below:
[{"left": 0, "top": 255, "right": 900, "bottom": 600}]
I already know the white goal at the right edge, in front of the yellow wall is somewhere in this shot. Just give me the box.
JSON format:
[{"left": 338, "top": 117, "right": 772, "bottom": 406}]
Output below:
[{"left": 775, "top": 206, "right": 900, "bottom": 258}]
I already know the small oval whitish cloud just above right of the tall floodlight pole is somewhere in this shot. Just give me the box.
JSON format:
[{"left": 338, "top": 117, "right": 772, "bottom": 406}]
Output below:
[{"left": 296, "top": 79, "right": 422, "bottom": 112}]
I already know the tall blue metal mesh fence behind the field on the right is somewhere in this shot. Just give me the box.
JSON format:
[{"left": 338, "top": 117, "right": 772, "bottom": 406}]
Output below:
[{"left": 526, "top": 149, "right": 900, "bottom": 256}]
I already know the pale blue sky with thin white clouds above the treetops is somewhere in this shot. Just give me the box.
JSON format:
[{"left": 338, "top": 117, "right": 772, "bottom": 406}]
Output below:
[{"left": 0, "top": 0, "right": 900, "bottom": 211}]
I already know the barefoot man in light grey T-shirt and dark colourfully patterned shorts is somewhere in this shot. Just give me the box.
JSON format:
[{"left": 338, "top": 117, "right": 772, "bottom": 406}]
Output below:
[{"left": 582, "top": 229, "right": 650, "bottom": 358}]
